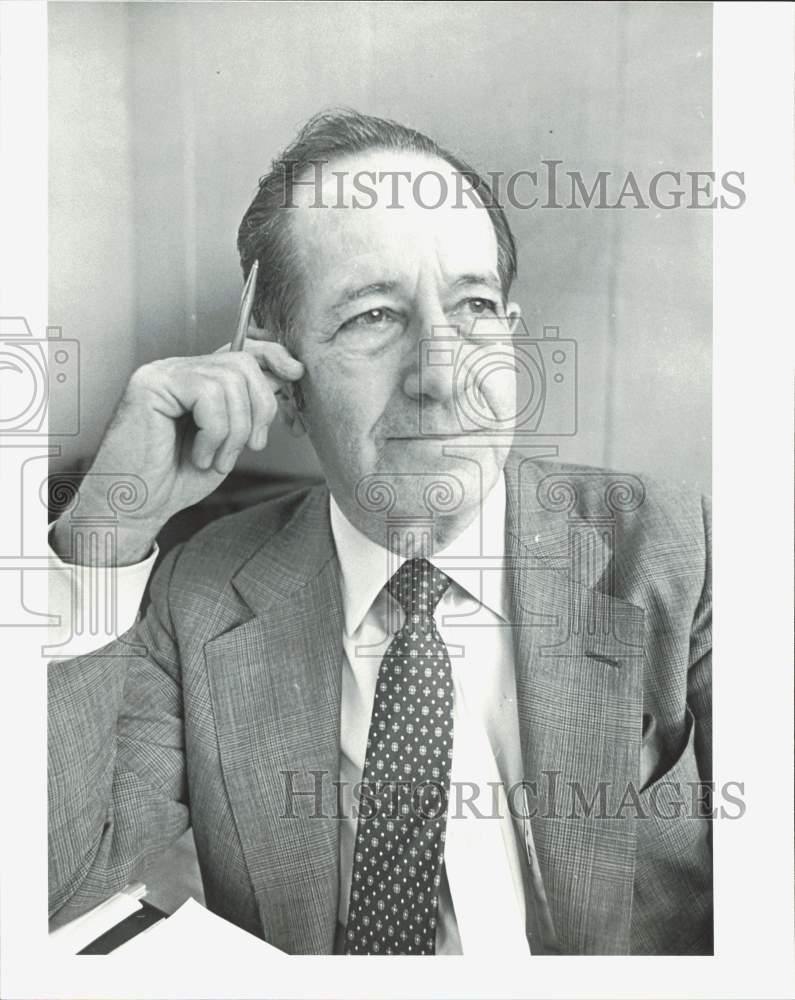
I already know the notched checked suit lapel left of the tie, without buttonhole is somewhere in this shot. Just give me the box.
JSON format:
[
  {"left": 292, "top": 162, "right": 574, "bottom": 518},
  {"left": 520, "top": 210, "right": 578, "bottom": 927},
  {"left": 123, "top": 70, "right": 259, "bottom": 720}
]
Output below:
[{"left": 205, "top": 491, "right": 343, "bottom": 954}]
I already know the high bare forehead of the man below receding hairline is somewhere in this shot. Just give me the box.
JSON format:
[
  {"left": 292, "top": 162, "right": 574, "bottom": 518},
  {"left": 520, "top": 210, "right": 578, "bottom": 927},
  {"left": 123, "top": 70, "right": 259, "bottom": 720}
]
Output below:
[{"left": 290, "top": 150, "right": 497, "bottom": 285}]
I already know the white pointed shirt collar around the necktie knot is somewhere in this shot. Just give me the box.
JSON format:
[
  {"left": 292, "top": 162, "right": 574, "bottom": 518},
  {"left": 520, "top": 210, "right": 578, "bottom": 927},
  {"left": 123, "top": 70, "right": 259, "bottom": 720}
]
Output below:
[{"left": 330, "top": 474, "right": 508, "bottom": 635}]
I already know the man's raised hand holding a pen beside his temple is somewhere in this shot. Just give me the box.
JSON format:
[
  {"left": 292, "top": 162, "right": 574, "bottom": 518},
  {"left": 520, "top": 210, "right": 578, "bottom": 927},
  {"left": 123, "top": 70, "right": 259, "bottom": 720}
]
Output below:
[{"left": 53, "top": 337, "right": 304, "bottom": 565}]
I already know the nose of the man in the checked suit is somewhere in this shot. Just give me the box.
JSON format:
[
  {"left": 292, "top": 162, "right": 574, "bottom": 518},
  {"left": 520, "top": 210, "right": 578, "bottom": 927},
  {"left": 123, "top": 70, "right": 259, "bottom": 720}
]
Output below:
[{"left": 403, "top": 294, "right": 456, "bottom": 403}]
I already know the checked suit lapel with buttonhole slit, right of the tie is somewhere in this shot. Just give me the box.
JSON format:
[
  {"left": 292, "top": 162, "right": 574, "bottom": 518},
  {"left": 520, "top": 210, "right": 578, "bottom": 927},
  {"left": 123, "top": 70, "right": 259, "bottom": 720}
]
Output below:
[{"left": 506, "top": 463, "right": 644, "bottom": 954}]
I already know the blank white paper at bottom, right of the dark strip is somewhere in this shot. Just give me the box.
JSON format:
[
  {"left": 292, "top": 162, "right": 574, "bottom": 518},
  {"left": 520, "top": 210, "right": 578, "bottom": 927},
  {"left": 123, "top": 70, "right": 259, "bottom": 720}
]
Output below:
[{"left": 109, "top": 898, "right": 287, "bottom": 963}]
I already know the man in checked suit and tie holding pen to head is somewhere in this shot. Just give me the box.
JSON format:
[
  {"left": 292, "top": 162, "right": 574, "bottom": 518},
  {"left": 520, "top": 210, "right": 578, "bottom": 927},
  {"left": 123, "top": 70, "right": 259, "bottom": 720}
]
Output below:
[{"left": 49, "top": 112, "right": 712, "bottom": 954}]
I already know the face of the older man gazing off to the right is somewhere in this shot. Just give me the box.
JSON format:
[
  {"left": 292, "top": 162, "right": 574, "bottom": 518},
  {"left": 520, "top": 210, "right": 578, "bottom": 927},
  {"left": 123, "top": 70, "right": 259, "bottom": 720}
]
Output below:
[{"left": 291, "top": 152, "right": 518, "bottom": 543}]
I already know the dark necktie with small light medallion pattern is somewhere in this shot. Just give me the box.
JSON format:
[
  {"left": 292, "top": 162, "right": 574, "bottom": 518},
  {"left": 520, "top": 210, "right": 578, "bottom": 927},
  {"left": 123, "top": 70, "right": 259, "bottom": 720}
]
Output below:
[{"left": 345, "top": 559, "right": 453, "bottom": 955}]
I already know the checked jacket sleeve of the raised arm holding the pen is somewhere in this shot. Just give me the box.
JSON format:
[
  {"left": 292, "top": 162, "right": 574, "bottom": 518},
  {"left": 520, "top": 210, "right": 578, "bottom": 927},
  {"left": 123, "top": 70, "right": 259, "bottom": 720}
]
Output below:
[{"left": 47, "top": 546, "right": 189, "bottom": 926}]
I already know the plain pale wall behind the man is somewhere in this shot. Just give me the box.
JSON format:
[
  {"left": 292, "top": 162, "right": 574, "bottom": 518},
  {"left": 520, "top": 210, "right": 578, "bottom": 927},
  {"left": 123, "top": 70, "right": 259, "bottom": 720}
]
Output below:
[{"left": 49, "top": 3, "right": 712, "bottom": 489}]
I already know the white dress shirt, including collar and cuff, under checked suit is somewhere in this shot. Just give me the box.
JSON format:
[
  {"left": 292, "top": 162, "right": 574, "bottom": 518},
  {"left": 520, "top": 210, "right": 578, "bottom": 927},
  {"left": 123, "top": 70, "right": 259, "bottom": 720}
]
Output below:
[{"left": 49, "top": 477, "right": 529, "bottom": 956}]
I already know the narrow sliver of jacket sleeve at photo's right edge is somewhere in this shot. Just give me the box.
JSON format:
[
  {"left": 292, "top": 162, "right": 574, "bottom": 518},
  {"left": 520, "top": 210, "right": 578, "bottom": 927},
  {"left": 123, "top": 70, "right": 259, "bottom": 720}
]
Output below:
[{"left": 687, "top": 497, "right": 712, "bottom": 782}]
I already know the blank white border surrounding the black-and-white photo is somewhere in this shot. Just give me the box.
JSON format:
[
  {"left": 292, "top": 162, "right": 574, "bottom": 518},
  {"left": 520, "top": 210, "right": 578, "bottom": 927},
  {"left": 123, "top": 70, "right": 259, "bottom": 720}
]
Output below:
[{"left": 0, "top": 0, "right": 795, "bottom": 1000}]
